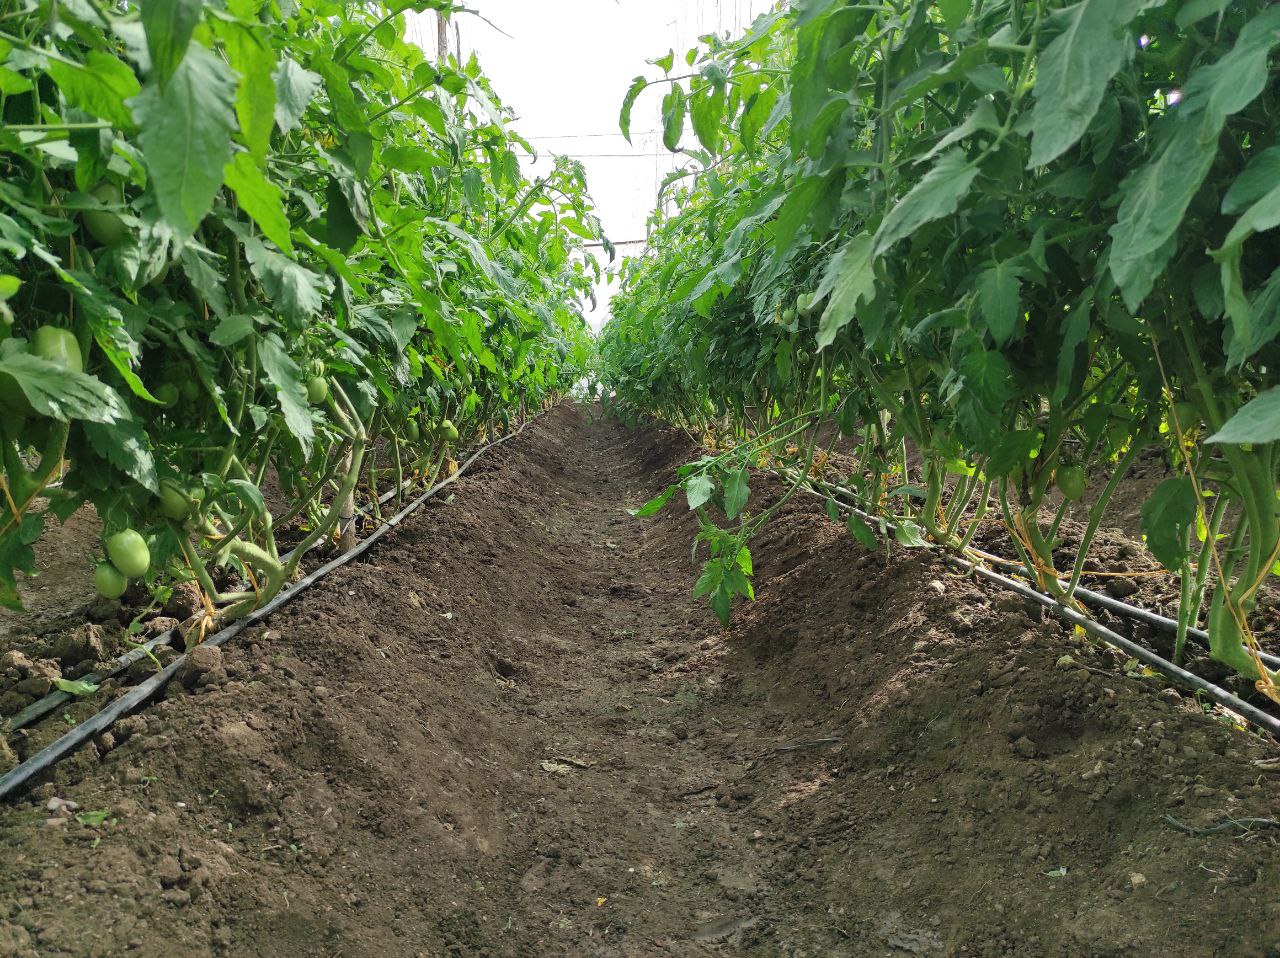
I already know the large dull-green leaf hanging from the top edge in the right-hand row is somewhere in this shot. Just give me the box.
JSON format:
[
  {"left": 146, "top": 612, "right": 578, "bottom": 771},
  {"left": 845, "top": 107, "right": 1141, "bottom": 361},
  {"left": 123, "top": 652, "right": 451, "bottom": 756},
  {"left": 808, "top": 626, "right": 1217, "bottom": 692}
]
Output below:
[{"left": 1027, "top": 0, "right": 1164, "bottom": 168}]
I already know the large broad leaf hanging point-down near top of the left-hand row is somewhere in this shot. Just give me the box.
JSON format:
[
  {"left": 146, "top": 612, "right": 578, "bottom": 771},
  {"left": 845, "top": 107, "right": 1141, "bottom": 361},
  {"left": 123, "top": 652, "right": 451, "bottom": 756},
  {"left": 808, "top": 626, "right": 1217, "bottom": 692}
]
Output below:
[{"left": 132, "top": 44, "right": 236, "bottom": 238}]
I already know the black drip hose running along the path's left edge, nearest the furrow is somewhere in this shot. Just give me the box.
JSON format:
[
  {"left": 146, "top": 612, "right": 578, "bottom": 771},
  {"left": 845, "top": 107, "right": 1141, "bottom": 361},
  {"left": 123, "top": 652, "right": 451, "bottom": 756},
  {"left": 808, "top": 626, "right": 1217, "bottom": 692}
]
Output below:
[{"left": 0, "top": 410, "right": 549, "bottom": 799}]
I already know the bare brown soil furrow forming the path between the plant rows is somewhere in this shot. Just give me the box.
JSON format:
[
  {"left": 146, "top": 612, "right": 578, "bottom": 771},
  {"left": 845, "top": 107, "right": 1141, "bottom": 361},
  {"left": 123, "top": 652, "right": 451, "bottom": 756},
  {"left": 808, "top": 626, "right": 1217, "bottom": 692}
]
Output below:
[{"left": 0, "top": 406, "right": 1280, "bottom": 958}]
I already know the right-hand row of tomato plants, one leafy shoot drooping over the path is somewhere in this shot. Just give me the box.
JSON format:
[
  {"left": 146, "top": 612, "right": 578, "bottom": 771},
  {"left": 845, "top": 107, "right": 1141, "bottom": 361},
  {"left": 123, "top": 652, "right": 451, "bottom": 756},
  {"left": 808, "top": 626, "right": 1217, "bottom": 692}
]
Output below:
[{"left": 600, "top": 0, "right": 1280, "bottom": 701}]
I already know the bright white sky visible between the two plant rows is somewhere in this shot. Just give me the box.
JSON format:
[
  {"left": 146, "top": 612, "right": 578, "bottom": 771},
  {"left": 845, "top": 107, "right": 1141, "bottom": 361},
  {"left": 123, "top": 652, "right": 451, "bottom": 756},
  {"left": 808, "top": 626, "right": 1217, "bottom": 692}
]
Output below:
[{"left": 415, "top": 0, "right": 773, "bottom": 329}]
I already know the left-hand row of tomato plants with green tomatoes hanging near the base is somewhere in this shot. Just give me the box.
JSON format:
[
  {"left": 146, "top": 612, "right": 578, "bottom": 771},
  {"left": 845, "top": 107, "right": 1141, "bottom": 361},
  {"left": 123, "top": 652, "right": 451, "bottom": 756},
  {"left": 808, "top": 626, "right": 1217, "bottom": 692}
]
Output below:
[{"left": 0, "top": 0, "right": 600, "bottom": 635}]
